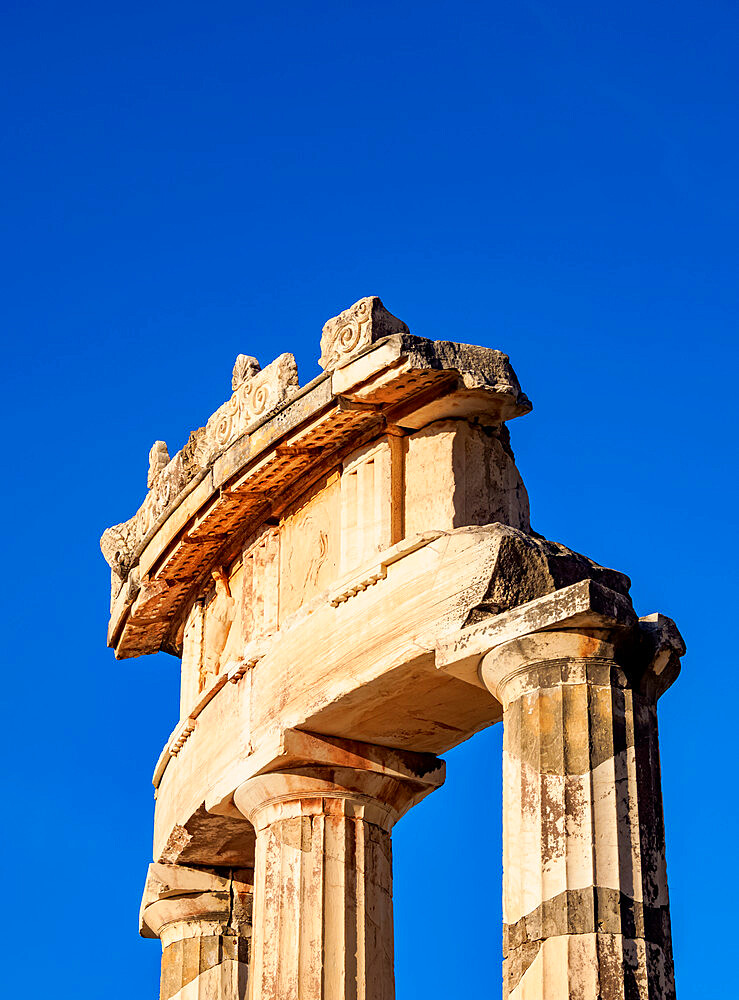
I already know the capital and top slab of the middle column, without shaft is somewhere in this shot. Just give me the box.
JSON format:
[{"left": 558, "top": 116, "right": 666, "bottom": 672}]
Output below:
[{"left": 234, "top": 733, "right": 445, "bottom": 833}]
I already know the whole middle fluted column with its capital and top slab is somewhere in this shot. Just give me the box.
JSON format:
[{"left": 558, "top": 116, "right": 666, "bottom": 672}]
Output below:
[{"left": 234, "top": 738, "right": 444, "bottom": 1000}]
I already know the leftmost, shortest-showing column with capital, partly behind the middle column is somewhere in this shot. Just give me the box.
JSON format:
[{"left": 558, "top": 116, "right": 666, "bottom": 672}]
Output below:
[{"left": 141, "top": 864, "right": 252, "bottom": 1000}]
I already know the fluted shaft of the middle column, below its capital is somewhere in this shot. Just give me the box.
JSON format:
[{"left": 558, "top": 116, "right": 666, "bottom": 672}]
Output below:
[{"left": 249, "top": 798, "right": 393, "bottom": 1000}]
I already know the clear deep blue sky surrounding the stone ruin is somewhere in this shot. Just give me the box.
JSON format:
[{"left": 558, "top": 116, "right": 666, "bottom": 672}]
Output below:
[{"left": 0, "top": 0, "right": 739, "bottom": 1000}]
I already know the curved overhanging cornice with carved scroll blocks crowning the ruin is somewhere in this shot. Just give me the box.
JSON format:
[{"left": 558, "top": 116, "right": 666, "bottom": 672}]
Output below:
[{"left": 101, "top": 298, "right": 531, "bottom": 658}]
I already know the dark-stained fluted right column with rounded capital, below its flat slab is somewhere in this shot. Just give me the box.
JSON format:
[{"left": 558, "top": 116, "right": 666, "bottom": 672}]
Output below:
[{"left": 480, "top": 613, "right": 684, "bottom": 1000}]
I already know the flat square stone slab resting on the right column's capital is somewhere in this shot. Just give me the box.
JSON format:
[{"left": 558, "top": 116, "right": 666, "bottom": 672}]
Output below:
[{"left": 436, "top": 580, "right": 638, "bottom": 688}]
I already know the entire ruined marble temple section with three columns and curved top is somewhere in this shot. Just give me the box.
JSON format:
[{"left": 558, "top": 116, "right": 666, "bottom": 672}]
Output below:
[{"left": 102, "top": 298, "right": 684, "bottom": 1000}]
